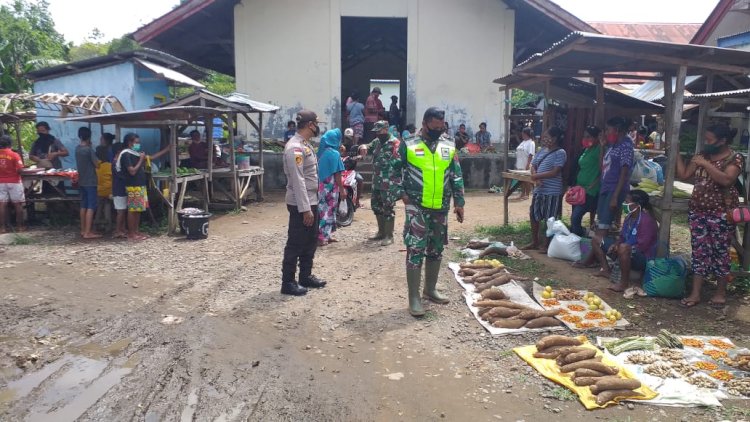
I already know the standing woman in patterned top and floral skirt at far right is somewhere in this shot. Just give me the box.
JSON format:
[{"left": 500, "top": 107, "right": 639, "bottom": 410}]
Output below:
[{"left": 676, "top": 125, "right": 745, "bottom": 308}]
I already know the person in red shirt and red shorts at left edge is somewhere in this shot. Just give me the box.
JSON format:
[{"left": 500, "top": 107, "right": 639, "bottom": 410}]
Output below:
[{"left": 0, "top": 135, "right": 26, "bottom": 233}]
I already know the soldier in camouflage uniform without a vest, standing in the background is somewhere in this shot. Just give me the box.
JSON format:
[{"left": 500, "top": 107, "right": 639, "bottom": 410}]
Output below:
[{"left": 359, "top": 120, "right": 401, "bottom": 246}]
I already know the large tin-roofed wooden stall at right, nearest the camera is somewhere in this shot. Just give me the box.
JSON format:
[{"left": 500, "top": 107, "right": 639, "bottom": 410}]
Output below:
[{"left": 496, "top": 32, "right": 750, "bottom": 261}]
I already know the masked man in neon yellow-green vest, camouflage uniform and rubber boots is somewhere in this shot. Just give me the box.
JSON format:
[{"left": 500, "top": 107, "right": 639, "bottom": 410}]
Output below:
[{"left": 399, "top": 107, "right": 464, "bottom": 317}]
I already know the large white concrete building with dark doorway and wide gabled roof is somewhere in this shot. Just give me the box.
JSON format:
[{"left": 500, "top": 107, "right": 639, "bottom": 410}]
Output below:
[{"left": 134, "top": 0, "right": 596, "bottom": 143}]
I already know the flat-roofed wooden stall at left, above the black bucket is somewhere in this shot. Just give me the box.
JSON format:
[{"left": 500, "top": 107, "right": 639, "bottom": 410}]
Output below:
[{"left": 65, "top": 106, "right": 222, "bottom": 234}]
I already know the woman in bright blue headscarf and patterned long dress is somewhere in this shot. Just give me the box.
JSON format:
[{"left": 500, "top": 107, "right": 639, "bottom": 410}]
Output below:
[{"left": 318, "top": 129, "right": 346, "bottom": 246}]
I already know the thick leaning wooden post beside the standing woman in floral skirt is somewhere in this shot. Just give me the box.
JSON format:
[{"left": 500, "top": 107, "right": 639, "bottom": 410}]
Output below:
[{"left": 656, "top": 66, "right": 687, "bottom": 257}]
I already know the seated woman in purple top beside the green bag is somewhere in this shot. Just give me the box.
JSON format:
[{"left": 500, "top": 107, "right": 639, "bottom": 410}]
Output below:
[{"left": 573, "top": 190, "right": 658, "bottom": 299}]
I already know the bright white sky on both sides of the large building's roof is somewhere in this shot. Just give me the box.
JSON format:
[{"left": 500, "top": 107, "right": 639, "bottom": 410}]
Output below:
[{"left": 0, "top": 0, "right": 718, "bottom": 44}]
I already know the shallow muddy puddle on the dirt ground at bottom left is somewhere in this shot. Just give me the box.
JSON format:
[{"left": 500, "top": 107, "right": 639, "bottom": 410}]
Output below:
[{"left": 0, "top": 339, "right": 138, "bottom": 422}]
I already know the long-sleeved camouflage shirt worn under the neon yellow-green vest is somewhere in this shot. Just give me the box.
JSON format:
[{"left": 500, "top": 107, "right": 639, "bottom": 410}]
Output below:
[{"left": 399, "top": 135, "right": 465, "bottom": 212}]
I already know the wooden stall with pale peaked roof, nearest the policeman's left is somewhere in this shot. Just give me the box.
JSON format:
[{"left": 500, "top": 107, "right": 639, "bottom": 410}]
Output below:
[{"left": 155, "top": 89, "right": 279, "bottom": 209}]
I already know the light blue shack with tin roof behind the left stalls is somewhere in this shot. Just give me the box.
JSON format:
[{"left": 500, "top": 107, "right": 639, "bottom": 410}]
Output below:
[{"left": 29, "top": 50, "right": 205, "bottom": 168}]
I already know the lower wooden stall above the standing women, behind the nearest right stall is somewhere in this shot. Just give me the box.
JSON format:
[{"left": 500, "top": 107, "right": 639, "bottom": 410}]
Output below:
[{"left": 494, "top": 74, "right": 664, "bottom": 225}]
